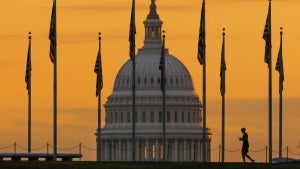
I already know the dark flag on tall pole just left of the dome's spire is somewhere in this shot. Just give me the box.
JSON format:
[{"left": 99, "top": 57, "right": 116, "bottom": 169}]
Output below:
[{"left": 129, "top": 0, "right": 136, "bottom": 60}]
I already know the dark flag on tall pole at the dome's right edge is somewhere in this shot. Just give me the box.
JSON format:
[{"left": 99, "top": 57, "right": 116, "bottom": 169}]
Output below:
[{"left": 197, "top": 2, "right": 205, "bottom": 65}]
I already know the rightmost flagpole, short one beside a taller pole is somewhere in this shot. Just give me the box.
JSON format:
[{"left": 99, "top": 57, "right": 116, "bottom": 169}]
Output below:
[{"left": 279, "top": 27, "right": 283, "bottom": 158}]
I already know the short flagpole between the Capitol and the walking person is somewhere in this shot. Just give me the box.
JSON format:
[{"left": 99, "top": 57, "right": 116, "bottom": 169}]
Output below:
[{"left": 221, "top": 28, "right": 225, "bottom": 162}]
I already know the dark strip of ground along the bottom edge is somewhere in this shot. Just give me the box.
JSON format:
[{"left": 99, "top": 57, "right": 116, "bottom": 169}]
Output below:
[{"left": 0, "top": 161, "right": 300, "bottom": 169}]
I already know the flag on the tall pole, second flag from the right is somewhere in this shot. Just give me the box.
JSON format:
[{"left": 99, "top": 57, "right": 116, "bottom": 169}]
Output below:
[{"left": 263, "top": 4, "right": 271, "bottom": 67}]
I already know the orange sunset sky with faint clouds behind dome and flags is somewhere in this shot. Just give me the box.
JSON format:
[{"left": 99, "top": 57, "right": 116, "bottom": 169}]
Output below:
[{"left": 0, "top": 0, "right": 300, "bottom": 161}]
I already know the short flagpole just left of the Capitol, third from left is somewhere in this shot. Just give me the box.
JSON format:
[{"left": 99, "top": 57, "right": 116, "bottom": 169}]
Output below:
[{"left": 97, "top": 32, "right": 101, "bottom": 161}]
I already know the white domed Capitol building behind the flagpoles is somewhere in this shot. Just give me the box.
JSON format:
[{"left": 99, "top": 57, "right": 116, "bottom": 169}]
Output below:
[{"left": 101, "top": 0, "right": 211, "bottom": 162}]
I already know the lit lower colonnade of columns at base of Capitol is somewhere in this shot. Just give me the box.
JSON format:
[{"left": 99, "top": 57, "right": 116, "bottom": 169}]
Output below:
[{"left": 101, "top": 138, "right": 210, "bottom": 162}]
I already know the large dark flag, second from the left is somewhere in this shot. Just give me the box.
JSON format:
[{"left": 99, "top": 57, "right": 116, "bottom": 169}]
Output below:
[{"left": 49, "top": 0, "right": 56, "bottom": 63}]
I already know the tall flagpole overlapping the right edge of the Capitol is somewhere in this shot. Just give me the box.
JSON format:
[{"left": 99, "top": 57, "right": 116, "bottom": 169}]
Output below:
[{"left": 202, "top": 0, "right": 210, "bottom": 162}]
